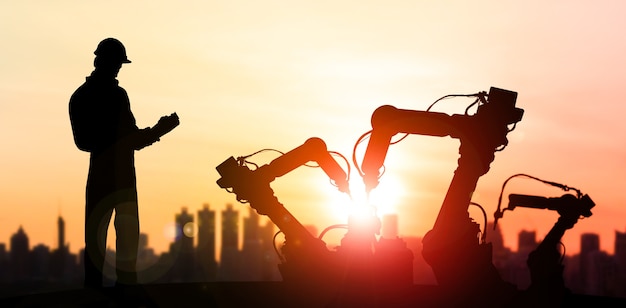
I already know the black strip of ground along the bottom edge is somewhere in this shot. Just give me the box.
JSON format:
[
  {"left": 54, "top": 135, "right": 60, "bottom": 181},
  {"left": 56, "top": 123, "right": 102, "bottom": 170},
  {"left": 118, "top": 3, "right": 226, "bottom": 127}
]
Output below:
[{"left": 0, "top": 282, "right": 626, "bottom": 307}]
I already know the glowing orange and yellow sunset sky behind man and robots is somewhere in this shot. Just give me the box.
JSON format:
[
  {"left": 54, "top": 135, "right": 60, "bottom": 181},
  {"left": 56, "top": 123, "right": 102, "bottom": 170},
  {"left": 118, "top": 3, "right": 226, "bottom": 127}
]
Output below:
[{"left": 0, "top": 0, "right": 626, "bottom": 254}]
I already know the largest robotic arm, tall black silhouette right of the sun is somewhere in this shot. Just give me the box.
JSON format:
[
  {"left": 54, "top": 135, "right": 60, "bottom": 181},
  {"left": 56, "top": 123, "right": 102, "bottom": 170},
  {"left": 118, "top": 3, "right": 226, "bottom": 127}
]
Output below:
[{"left": 362, "top": 87, "right": 524, "bottom": 300}]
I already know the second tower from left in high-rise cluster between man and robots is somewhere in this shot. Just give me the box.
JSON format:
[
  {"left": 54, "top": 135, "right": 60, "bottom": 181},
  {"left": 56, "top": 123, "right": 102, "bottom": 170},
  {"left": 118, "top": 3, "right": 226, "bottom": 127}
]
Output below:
[{"left": 196, "top": 204, "right": 217, "bottom": 281}]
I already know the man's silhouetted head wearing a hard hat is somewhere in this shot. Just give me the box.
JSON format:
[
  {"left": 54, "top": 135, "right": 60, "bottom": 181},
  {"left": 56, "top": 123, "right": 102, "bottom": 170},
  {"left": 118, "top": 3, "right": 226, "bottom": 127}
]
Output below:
[{"left": 93, "top": 38, "right": 131, "bottom": 78}]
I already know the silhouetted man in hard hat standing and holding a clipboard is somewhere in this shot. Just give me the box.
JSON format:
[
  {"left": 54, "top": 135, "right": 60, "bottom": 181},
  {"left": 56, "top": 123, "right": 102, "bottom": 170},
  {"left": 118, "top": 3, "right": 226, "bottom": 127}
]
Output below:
[{"left": 69, "top": 38, "right": 179, "bottom": 288}]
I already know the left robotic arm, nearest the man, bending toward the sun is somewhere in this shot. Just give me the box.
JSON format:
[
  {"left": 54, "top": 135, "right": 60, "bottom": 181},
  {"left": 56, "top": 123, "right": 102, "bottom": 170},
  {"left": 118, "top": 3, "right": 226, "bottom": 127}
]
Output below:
[{"left": 216, "top": 138, "right": 349, "bottom": 281}]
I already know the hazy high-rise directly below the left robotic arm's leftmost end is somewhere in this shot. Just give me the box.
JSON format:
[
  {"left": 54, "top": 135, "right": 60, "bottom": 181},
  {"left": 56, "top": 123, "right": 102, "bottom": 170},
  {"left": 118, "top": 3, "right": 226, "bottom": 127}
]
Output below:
[{"left": 218, "top": 204, "right": 240, "bottom": 281}]
